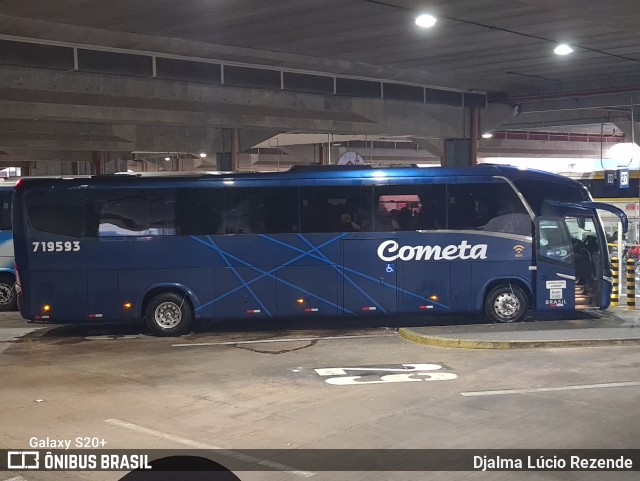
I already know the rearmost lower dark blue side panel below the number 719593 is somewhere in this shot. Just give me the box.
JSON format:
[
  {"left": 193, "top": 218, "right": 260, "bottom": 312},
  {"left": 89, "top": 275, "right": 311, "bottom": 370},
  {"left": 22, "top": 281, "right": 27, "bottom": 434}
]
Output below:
[{"left": 29, "top": 270, "right": 88, "bottom": 322}]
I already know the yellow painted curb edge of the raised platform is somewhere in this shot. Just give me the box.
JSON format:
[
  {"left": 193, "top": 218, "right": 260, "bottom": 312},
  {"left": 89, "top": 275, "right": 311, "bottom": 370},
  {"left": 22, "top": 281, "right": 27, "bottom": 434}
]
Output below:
[{"left": 398, "top": 327, "right": 640, "bottom": 349}]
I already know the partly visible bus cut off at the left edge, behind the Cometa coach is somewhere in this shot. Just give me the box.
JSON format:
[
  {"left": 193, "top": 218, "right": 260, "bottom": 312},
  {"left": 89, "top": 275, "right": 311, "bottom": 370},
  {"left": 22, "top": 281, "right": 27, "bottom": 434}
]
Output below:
[{"left": 0, "top": 181, "right": 18, "bottom": 311}]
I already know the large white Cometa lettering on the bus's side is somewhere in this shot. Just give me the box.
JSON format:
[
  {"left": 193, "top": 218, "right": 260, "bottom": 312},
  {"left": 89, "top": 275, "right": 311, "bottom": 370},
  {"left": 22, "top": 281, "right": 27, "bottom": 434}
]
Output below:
[{"left": 378, "top": 240, "right": 487, "bottom": 262}]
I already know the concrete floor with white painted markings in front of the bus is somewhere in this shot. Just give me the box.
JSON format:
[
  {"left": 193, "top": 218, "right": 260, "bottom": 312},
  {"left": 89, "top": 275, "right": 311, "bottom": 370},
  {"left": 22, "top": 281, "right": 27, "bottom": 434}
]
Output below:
[{"left": 0, "top": 314, "right": 640, "bottom": 481}]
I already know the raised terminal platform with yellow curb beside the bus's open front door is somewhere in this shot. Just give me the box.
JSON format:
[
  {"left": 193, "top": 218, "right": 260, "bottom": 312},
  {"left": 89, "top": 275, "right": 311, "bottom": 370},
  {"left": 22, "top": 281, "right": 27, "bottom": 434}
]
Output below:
[{"left": 398, "top": 300, "right": 640, "bottom": 349}]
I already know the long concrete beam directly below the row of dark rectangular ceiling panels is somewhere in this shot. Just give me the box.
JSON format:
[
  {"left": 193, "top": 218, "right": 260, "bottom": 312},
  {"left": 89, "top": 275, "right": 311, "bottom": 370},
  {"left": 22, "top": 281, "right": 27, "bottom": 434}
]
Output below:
[{"left": 0, "top": 67, "right": 465, "bottom": 138}]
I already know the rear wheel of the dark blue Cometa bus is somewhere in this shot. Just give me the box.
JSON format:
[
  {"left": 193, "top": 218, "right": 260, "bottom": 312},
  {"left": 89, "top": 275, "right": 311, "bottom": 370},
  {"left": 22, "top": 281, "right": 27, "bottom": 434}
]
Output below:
[{"left": 144, "top": 292, "right": 193, "bottom": 336}]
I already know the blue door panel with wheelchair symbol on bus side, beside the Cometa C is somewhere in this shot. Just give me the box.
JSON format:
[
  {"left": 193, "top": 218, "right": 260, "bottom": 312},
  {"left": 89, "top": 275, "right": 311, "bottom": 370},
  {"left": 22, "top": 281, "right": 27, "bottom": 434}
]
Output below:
[{"left": 342, "top": 233, "right": 397, "bottom": 315}]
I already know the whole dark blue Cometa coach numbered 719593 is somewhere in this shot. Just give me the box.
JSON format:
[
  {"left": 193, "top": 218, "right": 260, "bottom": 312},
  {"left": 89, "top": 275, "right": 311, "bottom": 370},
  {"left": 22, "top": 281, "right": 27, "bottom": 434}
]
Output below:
[{"left": 13, "top": 165, "right": 626, "bottom": 335}]
